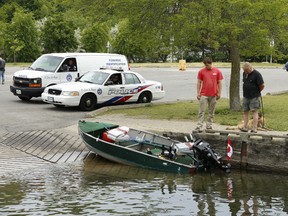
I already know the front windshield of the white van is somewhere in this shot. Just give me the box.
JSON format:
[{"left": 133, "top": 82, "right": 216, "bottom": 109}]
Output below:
[{"left": 29, "top": 55, "right": 63, "bottom": 72}]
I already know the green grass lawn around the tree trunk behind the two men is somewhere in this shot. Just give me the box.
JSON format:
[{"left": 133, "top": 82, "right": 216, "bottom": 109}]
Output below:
[{"left": 96, "top": 94, "right": 288, "bottom": 131}]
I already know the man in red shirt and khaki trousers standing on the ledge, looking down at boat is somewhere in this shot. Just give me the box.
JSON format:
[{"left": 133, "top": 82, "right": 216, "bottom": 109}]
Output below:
[{"left": 195, "top": 58, "right": 223, "bottom": 132}]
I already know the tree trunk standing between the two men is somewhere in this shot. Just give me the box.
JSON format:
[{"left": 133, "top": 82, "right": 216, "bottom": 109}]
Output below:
[{"left": 229, "top": 42, "right": 241, "bottom": 111}]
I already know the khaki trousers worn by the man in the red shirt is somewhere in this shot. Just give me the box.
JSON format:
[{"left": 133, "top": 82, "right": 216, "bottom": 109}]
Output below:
[{"left": 197, "top": 96, "right": 216, "bottom": 128}]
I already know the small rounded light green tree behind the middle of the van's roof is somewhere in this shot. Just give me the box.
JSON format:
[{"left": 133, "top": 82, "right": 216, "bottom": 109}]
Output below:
[{"left": 81, "top": 23, "right": 110, "bottom": 52}]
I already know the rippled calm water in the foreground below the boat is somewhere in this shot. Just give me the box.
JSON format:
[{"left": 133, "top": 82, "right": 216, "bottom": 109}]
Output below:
[{"left": 0, "top": 154, "right": 288, "bottom": 216}]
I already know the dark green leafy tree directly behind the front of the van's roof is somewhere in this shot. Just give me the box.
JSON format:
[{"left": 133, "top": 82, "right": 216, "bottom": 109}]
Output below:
[{"left": 41, "top": 14, "right": 78, "bottom": 53}]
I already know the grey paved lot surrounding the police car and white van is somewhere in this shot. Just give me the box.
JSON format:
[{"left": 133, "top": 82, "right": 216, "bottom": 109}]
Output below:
[{"left": 0, "top": 67, "right": 288, "bottom": 132}]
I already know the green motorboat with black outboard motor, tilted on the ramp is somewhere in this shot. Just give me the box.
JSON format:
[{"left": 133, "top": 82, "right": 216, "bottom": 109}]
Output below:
[{"left": 78, "top": 120, "right": 229, "bottom": 174}]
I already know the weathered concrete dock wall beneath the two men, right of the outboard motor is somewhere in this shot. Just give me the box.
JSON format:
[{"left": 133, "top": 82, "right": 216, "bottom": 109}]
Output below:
[{"left": 174, "top": 131, "right": 288, "bottom": 174}]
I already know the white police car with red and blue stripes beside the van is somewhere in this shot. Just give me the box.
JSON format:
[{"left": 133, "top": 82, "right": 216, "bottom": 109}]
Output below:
[{"left": 41, "top": 69, "right": 165, "bottom": 111}]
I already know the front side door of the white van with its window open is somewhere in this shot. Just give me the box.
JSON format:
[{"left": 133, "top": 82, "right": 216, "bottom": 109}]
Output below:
[{"left": 57, "top": 58, "right": 78, "bottom": 83}]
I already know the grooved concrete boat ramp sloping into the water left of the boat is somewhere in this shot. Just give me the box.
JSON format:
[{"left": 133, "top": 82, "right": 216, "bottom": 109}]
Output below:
[{"left": 0, "top": 130, "right": 90, "bottom": 176}]
